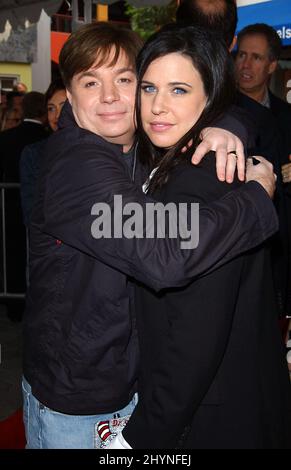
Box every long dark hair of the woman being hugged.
[136,24,235,192]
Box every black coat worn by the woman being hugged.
[123,155,291,449]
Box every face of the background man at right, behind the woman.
[235,34,277,99]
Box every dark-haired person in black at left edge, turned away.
[0,92,48,320]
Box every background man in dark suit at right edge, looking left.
[235,23,291,316]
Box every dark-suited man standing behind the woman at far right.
[235,23,291,315]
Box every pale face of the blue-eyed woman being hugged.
[141,53,207,148]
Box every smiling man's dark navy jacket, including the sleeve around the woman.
[24,104,277,414]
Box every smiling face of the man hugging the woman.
[67,50,136,151]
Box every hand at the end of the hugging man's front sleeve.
[246,156,277,198]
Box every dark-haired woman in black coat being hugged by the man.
[109,26,291,449]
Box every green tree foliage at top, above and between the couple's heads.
[125,0,177,39]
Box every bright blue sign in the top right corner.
[237,0,291,46]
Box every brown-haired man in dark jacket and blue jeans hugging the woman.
[23,23,276,448]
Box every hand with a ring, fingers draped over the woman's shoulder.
[192,127,246,183]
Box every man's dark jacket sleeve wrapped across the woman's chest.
[37,143,277,290]
